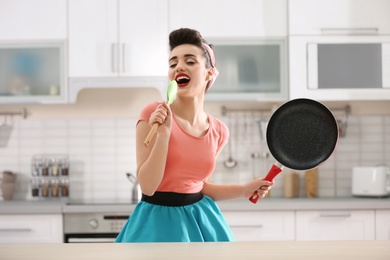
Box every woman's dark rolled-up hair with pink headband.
[169,28,213,68]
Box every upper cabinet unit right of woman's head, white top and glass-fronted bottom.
[169,0,288,102]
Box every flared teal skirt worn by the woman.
[115,196,235,243]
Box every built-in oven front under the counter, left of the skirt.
[64,212,130,243]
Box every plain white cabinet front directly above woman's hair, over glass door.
[169,0,287,39]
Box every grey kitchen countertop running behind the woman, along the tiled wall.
[0,197,390,214]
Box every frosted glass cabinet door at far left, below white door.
[0,40,68,104]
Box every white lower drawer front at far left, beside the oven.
[0,214,63,243]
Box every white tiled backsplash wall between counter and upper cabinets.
[0,116,390,201]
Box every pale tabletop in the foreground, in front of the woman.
[0,241,390,260]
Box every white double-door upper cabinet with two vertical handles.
[69,0,168,77]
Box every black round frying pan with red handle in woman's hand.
[249,98,339,203]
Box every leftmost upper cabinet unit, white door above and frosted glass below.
[0,0,67,104]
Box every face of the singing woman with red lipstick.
[168,44,212,94]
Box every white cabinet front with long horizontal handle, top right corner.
[289,0,390,35]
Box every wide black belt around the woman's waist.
[141,191,203,207]
